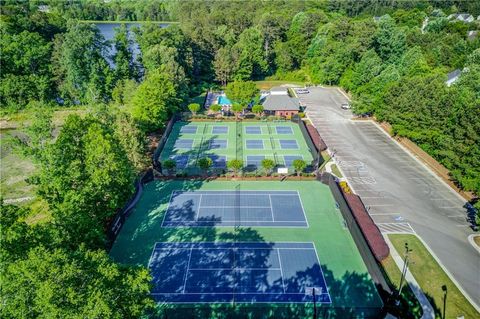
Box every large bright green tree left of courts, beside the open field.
[36,115,135,247]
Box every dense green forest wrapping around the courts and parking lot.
[0,0,480,318]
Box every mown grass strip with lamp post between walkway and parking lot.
[389,235,480,319]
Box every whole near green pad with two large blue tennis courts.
[109,179,382,318]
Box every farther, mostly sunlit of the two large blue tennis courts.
[162,190,308,227]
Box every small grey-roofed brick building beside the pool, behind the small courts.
[261,87,300,116]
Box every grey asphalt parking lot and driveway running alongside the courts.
[299,88,480,309]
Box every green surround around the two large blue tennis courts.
[110,180,382,318]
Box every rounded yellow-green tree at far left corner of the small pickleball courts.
[131,72,179,131]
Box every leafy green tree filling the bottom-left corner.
[2,247,154,318]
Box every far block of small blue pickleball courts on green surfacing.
[160,121,313,173]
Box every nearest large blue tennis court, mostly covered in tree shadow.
[148,242,331,303]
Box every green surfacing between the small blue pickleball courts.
[160,121,313,173]
